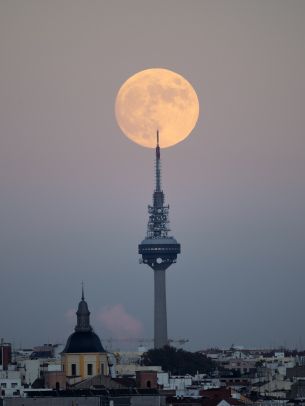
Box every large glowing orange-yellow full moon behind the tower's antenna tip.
[115,68,199,148]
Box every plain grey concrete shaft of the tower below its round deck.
[154,269,168,348]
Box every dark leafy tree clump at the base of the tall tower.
[141,346,216,375]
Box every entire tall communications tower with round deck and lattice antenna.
[139,131,180,348]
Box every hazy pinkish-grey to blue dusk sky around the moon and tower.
[0,0,305,349]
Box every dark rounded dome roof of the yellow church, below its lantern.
[63,331,105,354]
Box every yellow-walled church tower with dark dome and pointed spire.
[62,289,109,384]
